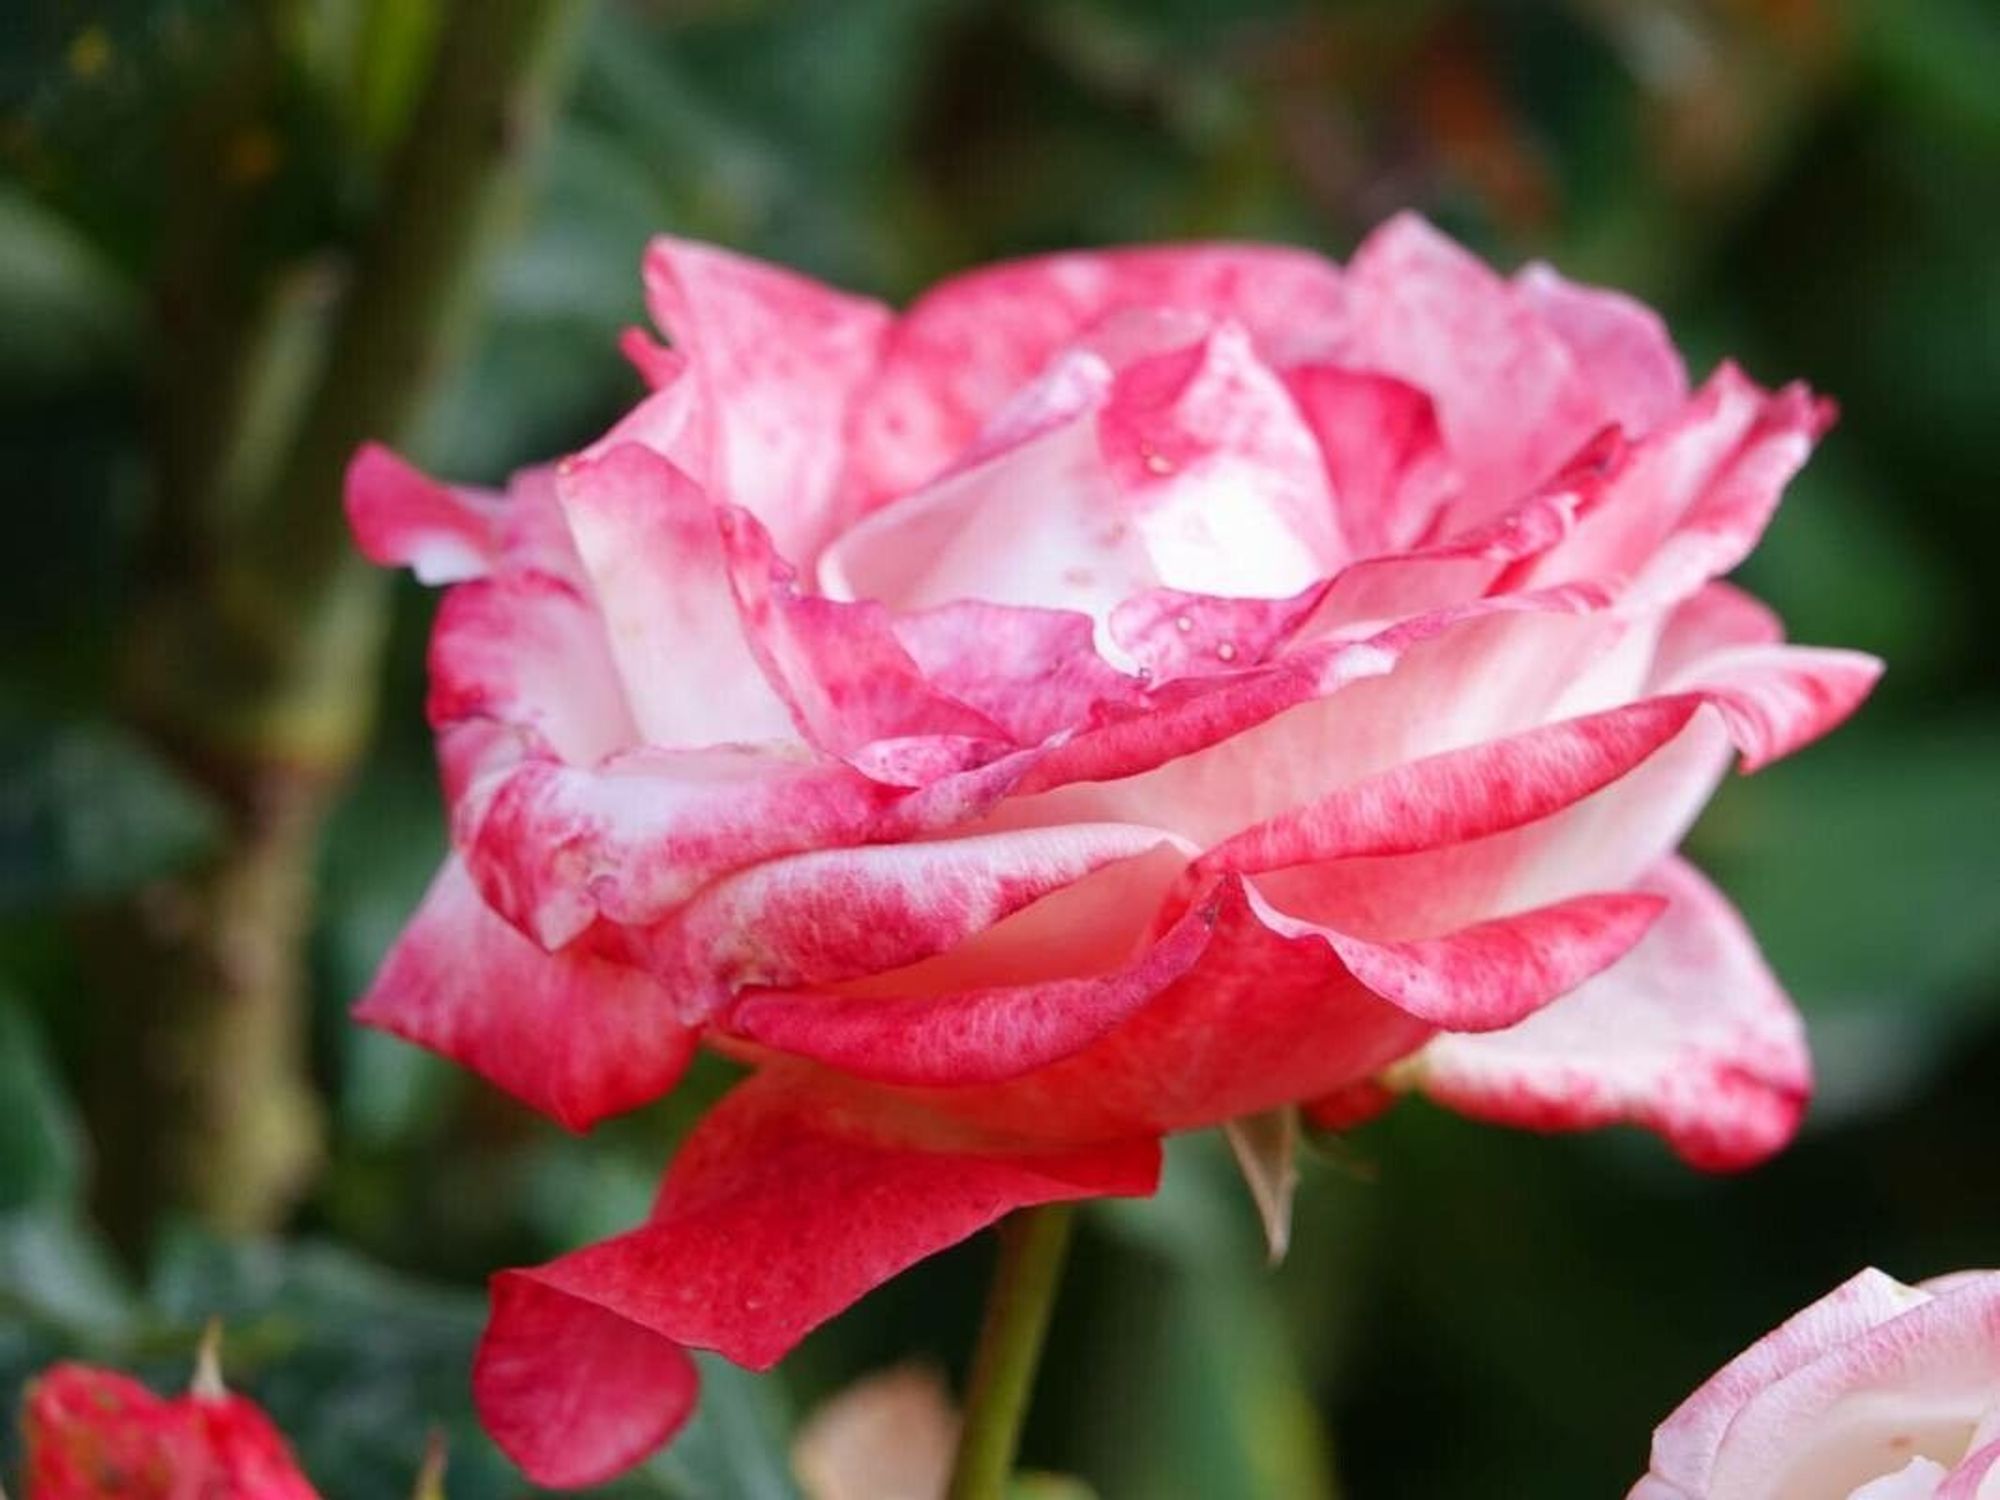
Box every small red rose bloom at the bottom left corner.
[22,1364,316,1500]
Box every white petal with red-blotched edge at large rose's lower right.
[1408,860,1812,1170]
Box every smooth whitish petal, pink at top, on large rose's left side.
[556,444,794,748]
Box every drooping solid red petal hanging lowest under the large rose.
[474,1076,1158,1486]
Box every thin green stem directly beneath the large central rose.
[950,1204,1076,1500]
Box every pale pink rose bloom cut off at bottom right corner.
[1630,1270,2000,1500]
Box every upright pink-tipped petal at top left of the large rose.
[646,236,890,560]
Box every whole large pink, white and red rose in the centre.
[348,218,1880,1484]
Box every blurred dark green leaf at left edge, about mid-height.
[0,724,222,908]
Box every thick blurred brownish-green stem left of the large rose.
[86,0,586,1252]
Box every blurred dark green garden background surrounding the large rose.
[0,0,2000,1500]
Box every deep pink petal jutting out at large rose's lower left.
[354,858,696,1130]
